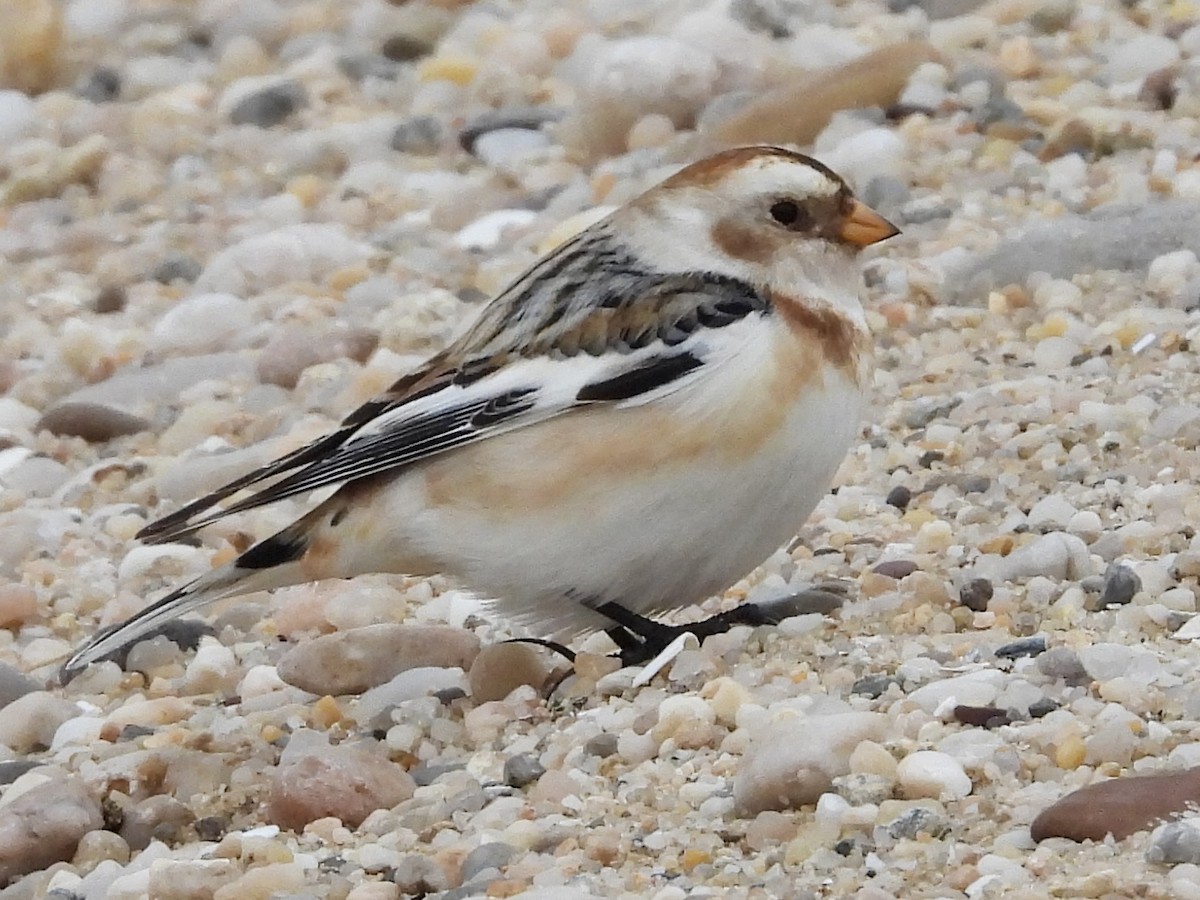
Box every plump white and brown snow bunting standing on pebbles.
[61,145,899,682]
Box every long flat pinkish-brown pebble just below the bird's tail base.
[276,623,479,696]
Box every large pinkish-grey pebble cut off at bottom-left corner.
[0,778,104,884]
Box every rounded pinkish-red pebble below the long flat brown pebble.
[266,734,415,830]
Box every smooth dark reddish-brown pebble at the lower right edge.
[1030,768,1200,841]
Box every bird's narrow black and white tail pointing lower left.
[59,520,308,684]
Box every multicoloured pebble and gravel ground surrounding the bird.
[0,0,1200,900]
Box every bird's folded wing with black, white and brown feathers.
[139,229,769,542]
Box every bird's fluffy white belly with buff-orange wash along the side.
[384,338,862,637]
